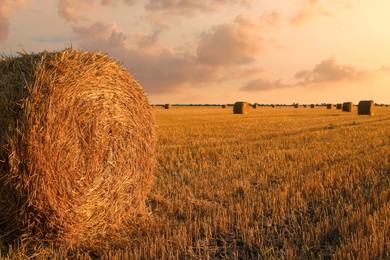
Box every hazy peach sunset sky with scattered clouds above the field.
[0,0,390,104]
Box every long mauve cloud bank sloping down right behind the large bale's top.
[73,23,218,94]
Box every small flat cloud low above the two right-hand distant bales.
[295,58,373,86]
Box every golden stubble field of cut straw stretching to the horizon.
[3,107,390,259]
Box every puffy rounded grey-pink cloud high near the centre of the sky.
[197,16,264,66]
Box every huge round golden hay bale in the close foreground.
[0,49,156,248]
